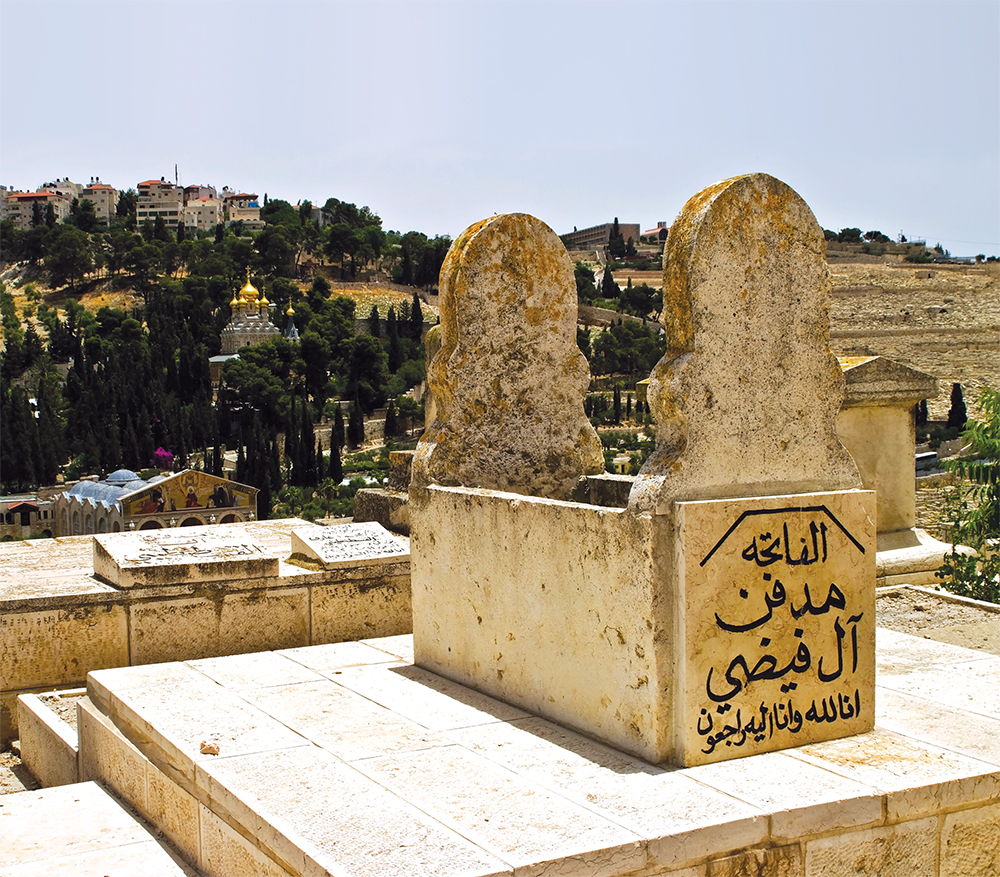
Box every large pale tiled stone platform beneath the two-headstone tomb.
[80,629,1000,877]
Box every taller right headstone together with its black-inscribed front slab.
[630,174,875,764]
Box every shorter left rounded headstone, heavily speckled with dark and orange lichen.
[413,213,604,499]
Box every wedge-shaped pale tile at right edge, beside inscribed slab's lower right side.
[879,656,1000,719]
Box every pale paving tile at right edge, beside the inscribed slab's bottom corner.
[875,687,1000,765]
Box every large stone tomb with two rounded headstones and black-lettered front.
[410,174,876,765]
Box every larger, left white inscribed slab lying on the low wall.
[94,527,279,588]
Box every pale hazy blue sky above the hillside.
[0,0,1000,255]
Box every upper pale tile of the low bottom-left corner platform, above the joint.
[0,783,158,866]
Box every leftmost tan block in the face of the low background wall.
[0,603,128,691]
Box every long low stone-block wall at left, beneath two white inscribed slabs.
[0,520,411,741]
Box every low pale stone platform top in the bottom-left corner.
[0,783,197,877]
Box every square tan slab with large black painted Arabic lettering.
[675,491,875,765]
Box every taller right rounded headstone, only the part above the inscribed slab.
[630,174,861,511]
